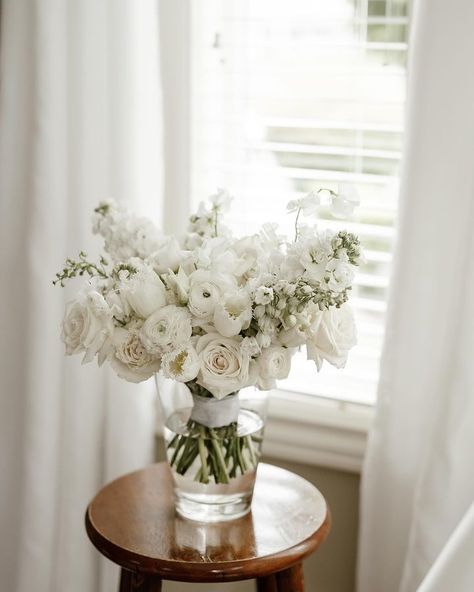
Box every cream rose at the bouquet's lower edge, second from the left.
[110,328,160,382]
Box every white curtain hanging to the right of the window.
[358,0,474,592]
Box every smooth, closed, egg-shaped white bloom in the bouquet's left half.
[119,266,166,319]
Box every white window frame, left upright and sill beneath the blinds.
[158,0,382,473]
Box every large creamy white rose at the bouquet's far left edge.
[61,291,114,363]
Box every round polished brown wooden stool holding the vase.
[86,463,330,592]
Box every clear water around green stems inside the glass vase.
[164,407,263,522]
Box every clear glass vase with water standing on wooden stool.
[157,377,267,522]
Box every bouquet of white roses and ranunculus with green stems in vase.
[54,189,361,483]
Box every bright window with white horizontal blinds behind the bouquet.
[190,0,409,404]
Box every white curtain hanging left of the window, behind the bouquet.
[0,0,162,592]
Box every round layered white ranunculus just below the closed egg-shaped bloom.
[140,304,192,354]
